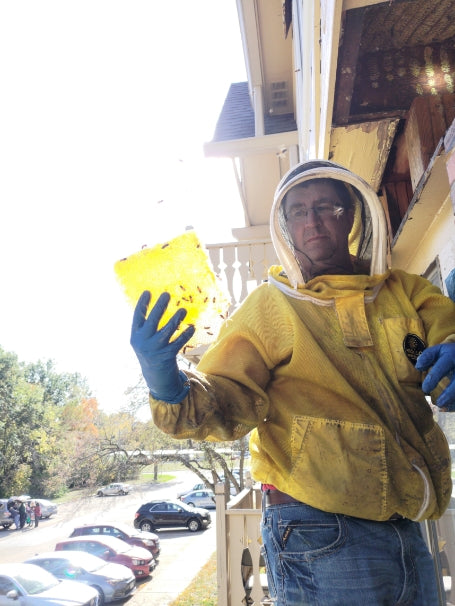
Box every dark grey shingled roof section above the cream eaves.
[212,82,297,143]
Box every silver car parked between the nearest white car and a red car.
[26,551,136,606]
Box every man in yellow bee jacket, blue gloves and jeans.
[131,161,455,606]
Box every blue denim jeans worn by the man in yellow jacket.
[261,503,438,606]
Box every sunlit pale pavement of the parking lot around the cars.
[0,471,216,606]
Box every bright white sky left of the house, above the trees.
[0,0,246,412]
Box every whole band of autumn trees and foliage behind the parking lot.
[0,348,246,498]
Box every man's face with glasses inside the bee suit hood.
[284,181,354,280]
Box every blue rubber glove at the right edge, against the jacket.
[416,343,455,412]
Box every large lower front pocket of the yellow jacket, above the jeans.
[291,416,388,520]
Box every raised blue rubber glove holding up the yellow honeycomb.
[130,291,194,404]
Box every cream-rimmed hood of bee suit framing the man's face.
[270,160,388,288]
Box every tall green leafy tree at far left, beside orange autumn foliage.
[0,349,94,496]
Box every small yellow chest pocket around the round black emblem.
[383,317,425,383]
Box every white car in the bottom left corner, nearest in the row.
[0,563,98,606]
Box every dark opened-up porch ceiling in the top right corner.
[332,0,455,126]
